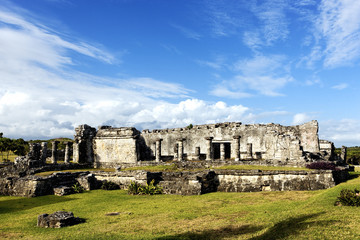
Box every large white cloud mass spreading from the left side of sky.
[0,4,253,139]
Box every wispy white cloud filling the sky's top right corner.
[309,0,360,67]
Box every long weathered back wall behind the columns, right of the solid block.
[141,121,319,161]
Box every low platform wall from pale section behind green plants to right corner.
[94,170,338,195]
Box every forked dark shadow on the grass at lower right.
[251,212,335,240]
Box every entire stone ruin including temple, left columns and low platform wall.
[0,121,348,197]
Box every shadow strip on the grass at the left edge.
[0,195,74,214]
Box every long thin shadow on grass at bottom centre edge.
[155,225,262,240]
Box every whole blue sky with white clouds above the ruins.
[0,0,360,146]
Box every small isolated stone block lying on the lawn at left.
[37,211,84,228]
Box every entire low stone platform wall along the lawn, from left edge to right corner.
[0,170,347,197]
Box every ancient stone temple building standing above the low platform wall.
[74,121,332,167]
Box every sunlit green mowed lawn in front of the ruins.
[0,175,360,239]
